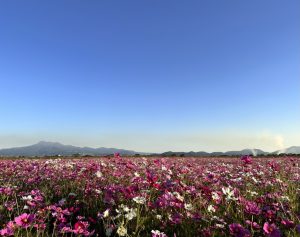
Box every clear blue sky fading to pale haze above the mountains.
[0,0,300,152]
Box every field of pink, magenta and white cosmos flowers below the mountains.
[0,156,300,237]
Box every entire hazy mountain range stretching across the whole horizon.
[0,141,300,157]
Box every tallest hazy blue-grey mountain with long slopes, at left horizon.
[0,141,137,156]
